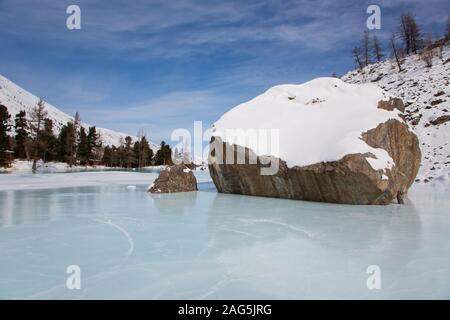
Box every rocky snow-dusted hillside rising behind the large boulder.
[342,45,450,182]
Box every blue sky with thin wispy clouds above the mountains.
[0,0,450,142]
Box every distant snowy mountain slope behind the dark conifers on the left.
[0,75,158,150]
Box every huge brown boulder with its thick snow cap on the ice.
[209,78,421,204]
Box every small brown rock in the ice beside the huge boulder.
[148,164,198,193]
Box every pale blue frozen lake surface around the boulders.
[0,172,450,299]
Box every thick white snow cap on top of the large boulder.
[213,78,400,170]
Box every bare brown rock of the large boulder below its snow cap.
[209,77,421,205]
